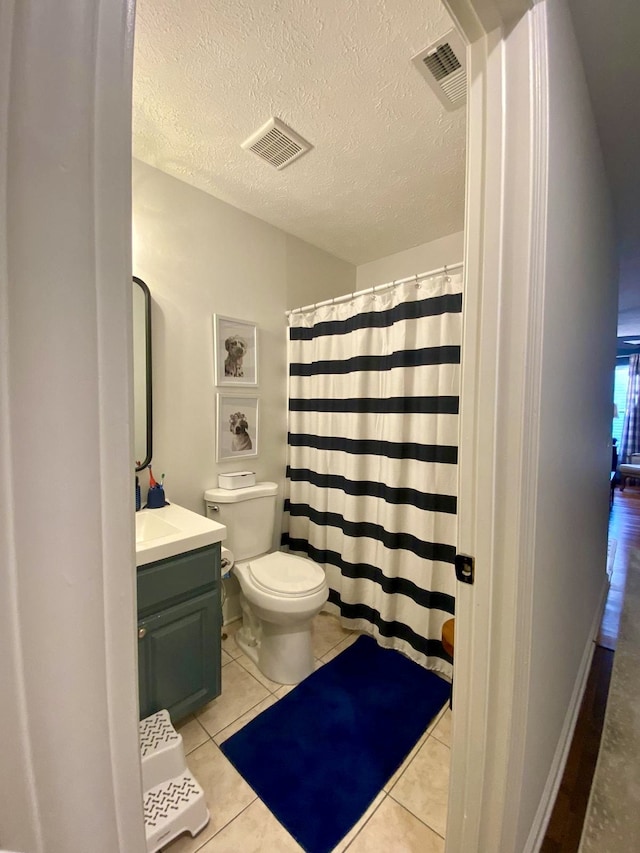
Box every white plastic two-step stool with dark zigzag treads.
[140,710,209,853]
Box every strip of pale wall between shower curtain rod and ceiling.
[356,231,464,290]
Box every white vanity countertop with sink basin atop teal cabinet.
[136,504,227,566]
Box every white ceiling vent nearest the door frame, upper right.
[411,30,467,110]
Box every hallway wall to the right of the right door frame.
[516,0,617,850]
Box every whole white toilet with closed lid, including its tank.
[204,483,329,684]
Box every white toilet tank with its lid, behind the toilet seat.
[204,483,278,560]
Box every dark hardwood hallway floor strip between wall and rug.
[540,487,640,853]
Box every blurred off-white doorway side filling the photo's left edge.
[0,0,146,853]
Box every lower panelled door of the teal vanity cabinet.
[138,589,220,720]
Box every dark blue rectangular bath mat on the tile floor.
[220,636,450,853]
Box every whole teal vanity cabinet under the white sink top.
[137,543,221,720]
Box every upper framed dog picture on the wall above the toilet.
[213,314,258,385]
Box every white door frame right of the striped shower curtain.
[443,0,548,853]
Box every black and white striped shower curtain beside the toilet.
[282,273,462,675]
